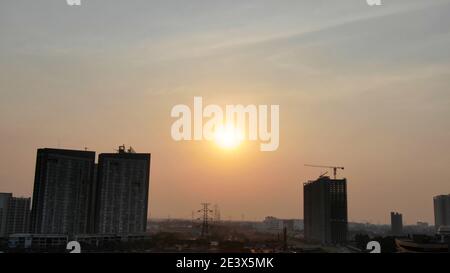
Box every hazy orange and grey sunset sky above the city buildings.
[0,0,450,224]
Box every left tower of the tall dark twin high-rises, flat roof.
[31,148,95,235]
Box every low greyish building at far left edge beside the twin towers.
[0,193,31,237]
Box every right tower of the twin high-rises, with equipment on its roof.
[95,146,150,234]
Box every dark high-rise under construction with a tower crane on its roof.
[303,176,348,244]
